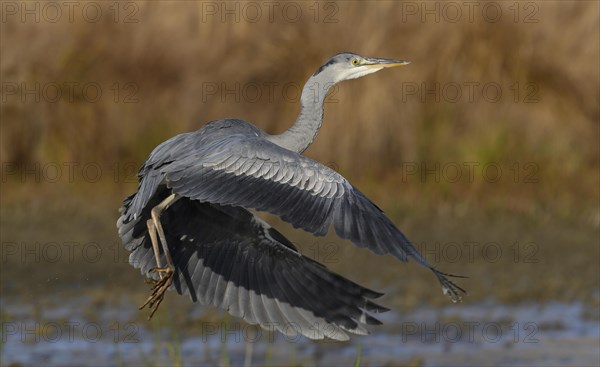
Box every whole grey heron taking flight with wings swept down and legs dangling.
[117,53,465,340]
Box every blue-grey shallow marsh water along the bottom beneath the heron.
[2,297,600,366]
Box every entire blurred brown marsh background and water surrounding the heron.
[0,1,600,366]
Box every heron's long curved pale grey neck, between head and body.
[268,73,333,153]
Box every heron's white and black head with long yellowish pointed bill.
[313,52,410,83]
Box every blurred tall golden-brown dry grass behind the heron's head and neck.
[0,1,600,216]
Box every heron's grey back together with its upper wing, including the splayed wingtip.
[125,120,465,302]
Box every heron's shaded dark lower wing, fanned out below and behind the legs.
[118,186,387,340]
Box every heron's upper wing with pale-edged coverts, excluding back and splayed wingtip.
[161,134,418,261]
